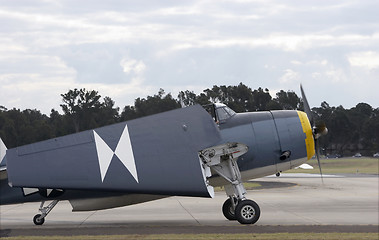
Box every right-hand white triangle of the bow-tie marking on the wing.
[115,125,138,183]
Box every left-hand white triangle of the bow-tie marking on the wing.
[93,131,114,182]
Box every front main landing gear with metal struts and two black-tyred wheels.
[199,143,261,224]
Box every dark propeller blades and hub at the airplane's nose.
[300,84,328,183]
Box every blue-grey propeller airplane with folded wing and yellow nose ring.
[0,85,327,225]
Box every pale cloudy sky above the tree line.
[0,0,379,114]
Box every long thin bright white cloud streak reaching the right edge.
[158,33,379,54]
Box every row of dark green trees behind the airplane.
[0,83,379,155]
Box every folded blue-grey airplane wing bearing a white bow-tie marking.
[7,105,221,197]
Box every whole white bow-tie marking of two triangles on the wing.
[93,125,138,183]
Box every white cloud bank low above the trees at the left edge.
[0,74,155,114]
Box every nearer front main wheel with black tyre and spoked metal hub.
[235,200,261,224]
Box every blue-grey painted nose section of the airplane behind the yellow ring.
[220,110,307,173]
